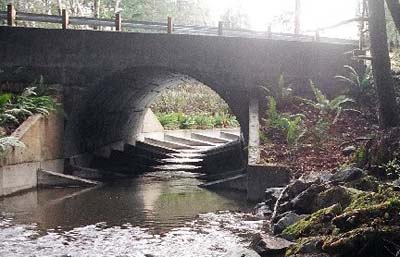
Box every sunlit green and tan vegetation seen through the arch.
[151,83,239,129]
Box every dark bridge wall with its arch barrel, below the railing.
[0,27,356,157]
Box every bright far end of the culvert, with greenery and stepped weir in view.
[136,79,244,174]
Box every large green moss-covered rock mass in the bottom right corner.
[282,184,400,257]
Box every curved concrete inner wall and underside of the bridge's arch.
[65,66,248,157]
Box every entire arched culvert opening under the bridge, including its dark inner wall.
[73,67,246,176]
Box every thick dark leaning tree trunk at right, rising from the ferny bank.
[368,0,399,128]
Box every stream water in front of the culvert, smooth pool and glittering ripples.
[0,172,261,257]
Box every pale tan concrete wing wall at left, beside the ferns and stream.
[0,114,64,196]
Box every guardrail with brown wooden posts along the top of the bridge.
[0,4,358,45]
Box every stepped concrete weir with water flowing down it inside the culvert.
[131,129,245,174]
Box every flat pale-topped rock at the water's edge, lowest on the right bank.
[250,234,294,256]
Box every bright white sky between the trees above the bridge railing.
[206,0,358,38]
